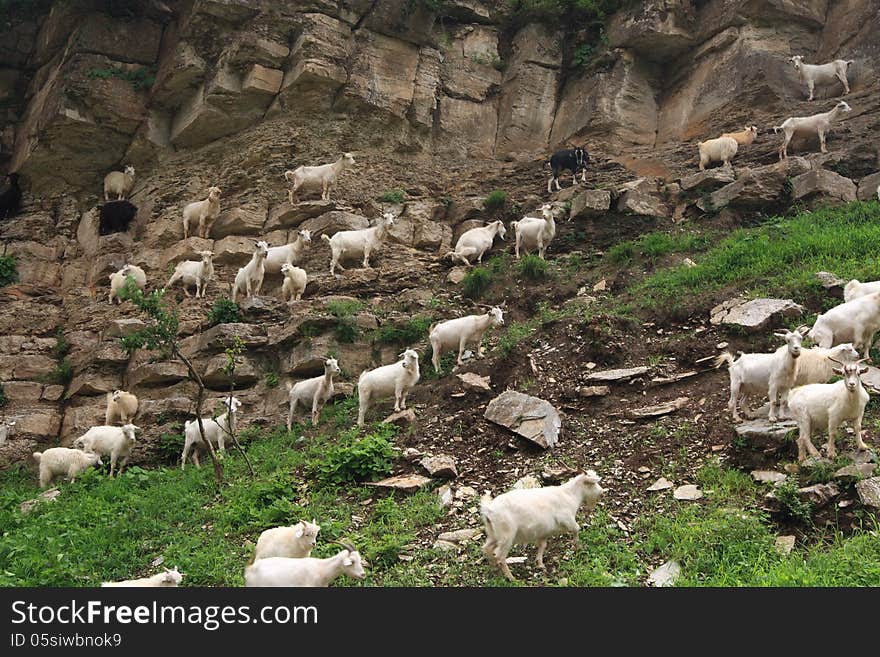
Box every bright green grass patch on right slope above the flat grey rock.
[630,201,880,308]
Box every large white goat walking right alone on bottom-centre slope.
[480,470,605,581]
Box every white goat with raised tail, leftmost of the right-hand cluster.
[715,326,807,422]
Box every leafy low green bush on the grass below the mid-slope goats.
[309,425,396,484]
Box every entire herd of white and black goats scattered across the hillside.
[4,51,880,586]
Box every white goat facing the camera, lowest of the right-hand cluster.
[788,359,869,462]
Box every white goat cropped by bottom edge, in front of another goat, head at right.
[244,549,369,587]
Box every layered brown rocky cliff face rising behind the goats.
[0,0,880,466]
